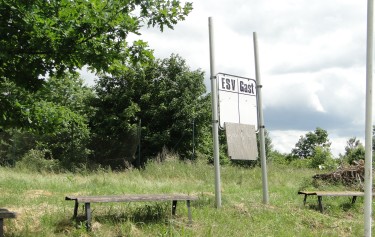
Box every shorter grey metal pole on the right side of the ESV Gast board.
[253,32,269,204]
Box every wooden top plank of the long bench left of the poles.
[65,194,198,203]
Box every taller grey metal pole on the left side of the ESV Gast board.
[208,17,221,208]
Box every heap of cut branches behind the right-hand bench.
[313,160,365,186]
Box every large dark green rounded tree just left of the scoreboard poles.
[91,55,210,166]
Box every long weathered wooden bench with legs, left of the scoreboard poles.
[65,194,198,230]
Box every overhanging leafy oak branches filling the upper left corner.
[0,0,192,89]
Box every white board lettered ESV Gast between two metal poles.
[217,73,258,129]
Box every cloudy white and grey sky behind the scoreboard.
[84,0,367,156]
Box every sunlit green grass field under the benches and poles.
[0,159,374,237]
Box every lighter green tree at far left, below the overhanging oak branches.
[0,73,93,168]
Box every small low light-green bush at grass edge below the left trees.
[16,149,60,173]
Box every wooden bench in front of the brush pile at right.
[298,191,374,212]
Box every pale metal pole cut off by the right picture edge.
[364,0,374,237]
